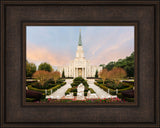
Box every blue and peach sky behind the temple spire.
[26,26,134,67]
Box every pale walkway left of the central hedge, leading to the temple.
[46,79,73,99]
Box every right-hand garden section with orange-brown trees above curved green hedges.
[95,68,134,102]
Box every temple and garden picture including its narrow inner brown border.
[23,23,138,105]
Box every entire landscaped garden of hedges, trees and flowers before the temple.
[26,60,134,103]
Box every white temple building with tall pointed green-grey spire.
[57,31,102,79]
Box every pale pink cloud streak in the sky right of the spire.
[88,33,134,65]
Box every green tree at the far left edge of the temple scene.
[26,60,36,77]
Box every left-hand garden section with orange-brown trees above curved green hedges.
[26,70,66,102]
